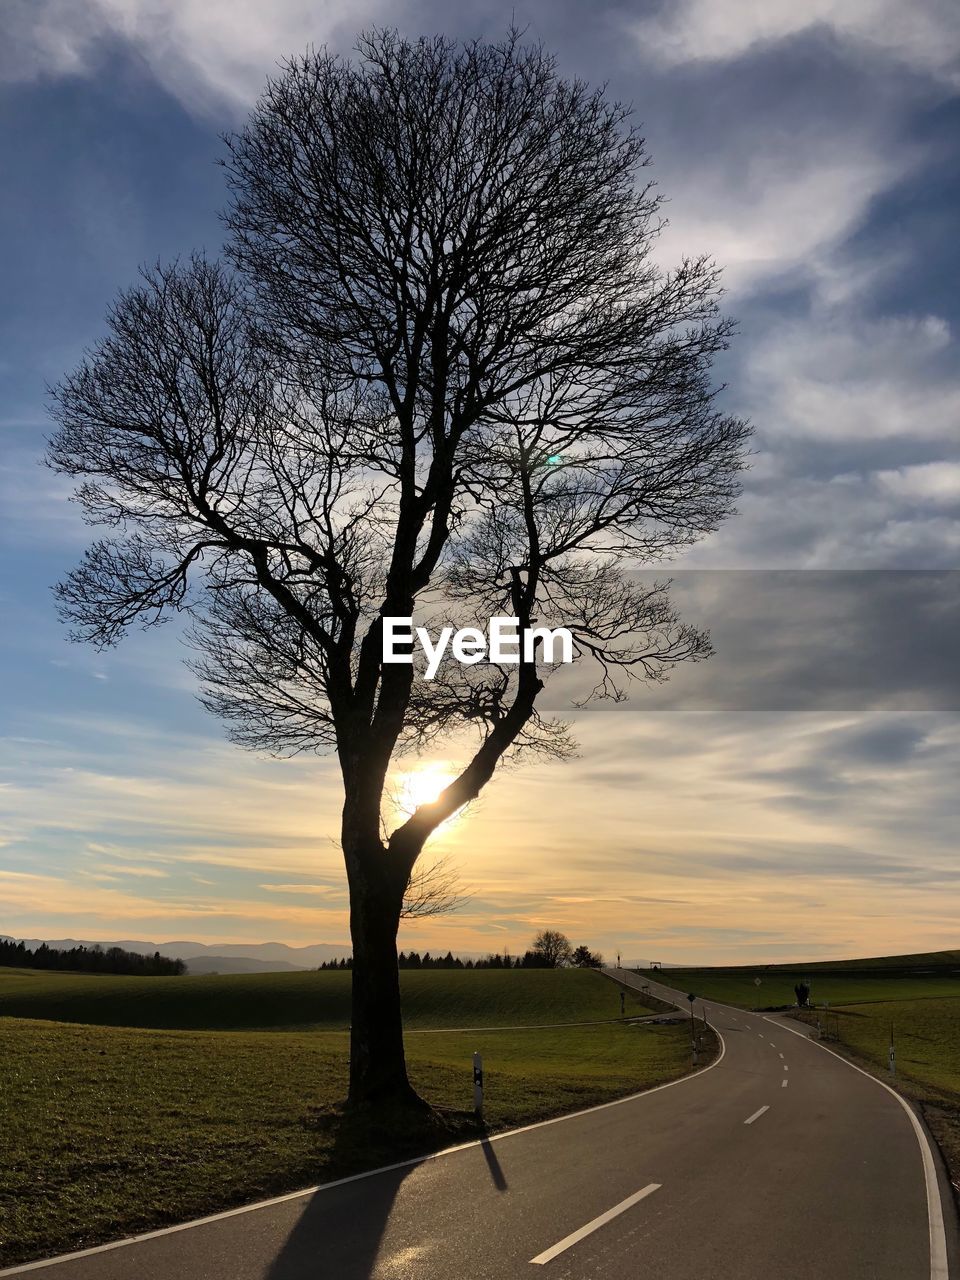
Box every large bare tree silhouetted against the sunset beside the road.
[50,32,748,1106]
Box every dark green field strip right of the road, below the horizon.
[641,965,960,1009]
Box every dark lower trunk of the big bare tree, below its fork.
[347,849,426,1110]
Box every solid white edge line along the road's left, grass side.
[0,1023,727,1280]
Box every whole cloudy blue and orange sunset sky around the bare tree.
[0,0,960,963]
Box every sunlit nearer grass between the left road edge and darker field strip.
[0,1008,708,1266]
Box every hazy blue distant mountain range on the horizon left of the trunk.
[0,934,351,974]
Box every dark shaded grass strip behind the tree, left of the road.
[0,969,646,1030]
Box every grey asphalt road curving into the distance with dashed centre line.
[0,974,955,1280]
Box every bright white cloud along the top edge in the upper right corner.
[631,0,960,84]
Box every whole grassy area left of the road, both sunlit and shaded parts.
[0,970,706,1265]
